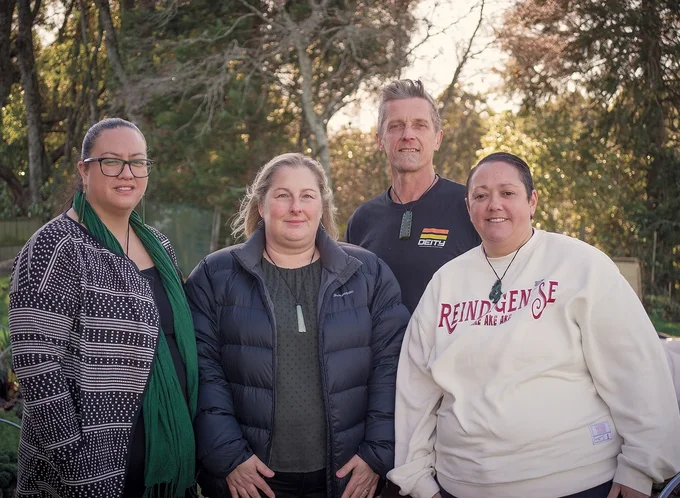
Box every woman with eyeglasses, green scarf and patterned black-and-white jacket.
[9,119,198,498]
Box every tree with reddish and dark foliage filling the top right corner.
[499,0,680,294]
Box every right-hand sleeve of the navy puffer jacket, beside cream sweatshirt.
[358,260,409,477]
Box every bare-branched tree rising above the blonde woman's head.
[136,0,416,178]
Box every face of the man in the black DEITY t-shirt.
[376,98,443,173]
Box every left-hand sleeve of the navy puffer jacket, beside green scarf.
[186,260,253,477]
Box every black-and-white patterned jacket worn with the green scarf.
[9,215,176,498]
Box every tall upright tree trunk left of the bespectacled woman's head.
[16,0,45,204]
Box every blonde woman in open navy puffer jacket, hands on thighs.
[187,154,409,498]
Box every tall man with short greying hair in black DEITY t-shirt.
[345,80,480,313]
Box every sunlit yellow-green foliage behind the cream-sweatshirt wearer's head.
[480,93,645,257]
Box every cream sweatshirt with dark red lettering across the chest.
[388,230,680,498]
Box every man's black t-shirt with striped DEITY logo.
[345,178,481,313]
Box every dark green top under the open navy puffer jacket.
[262,258,326,472]
